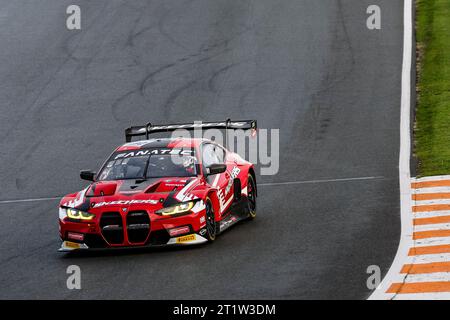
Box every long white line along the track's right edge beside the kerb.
[369,0,413,299]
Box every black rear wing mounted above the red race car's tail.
[125,119,257,142]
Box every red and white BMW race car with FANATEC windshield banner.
[59,120,257,251]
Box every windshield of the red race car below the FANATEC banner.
[99,155,197,180]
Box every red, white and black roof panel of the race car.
[116,138,212,151]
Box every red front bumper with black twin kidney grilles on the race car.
[58,206,207,252]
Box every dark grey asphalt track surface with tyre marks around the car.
[0,0,403,299]
